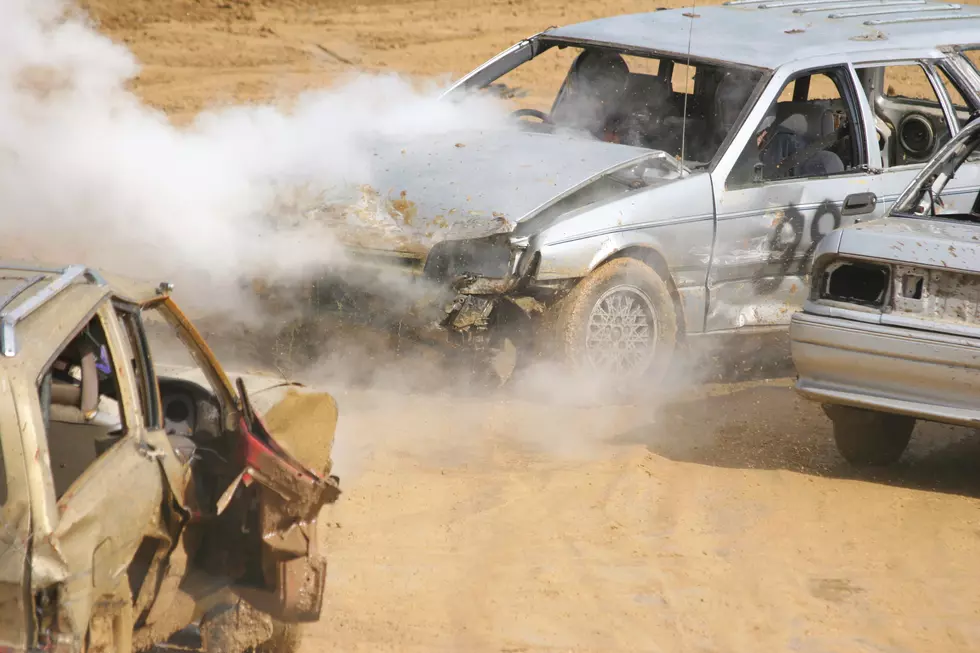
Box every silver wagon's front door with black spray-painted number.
[705,65,878,331]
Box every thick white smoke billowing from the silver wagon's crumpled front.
[0,0,505,308]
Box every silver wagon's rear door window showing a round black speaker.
[862,63,962,168]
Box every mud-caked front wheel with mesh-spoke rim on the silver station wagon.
[556,258,677,383]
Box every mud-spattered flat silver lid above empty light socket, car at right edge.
[838,217,980,272]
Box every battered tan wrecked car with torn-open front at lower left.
[0,264,339,653]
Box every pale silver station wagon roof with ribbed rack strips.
[544,0,980,69]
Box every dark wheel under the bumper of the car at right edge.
[824,405,915,467]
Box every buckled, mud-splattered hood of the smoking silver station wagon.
[310,130,659,254]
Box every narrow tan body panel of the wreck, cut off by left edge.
[0,372,33,650]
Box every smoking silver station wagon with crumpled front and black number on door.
[310,0,980,379]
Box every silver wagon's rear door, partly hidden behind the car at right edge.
[854,59,980,213]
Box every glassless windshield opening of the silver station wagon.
[472,41,763,165]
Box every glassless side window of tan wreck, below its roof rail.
[38,315,127,499]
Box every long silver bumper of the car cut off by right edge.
[790,312,980,427]
